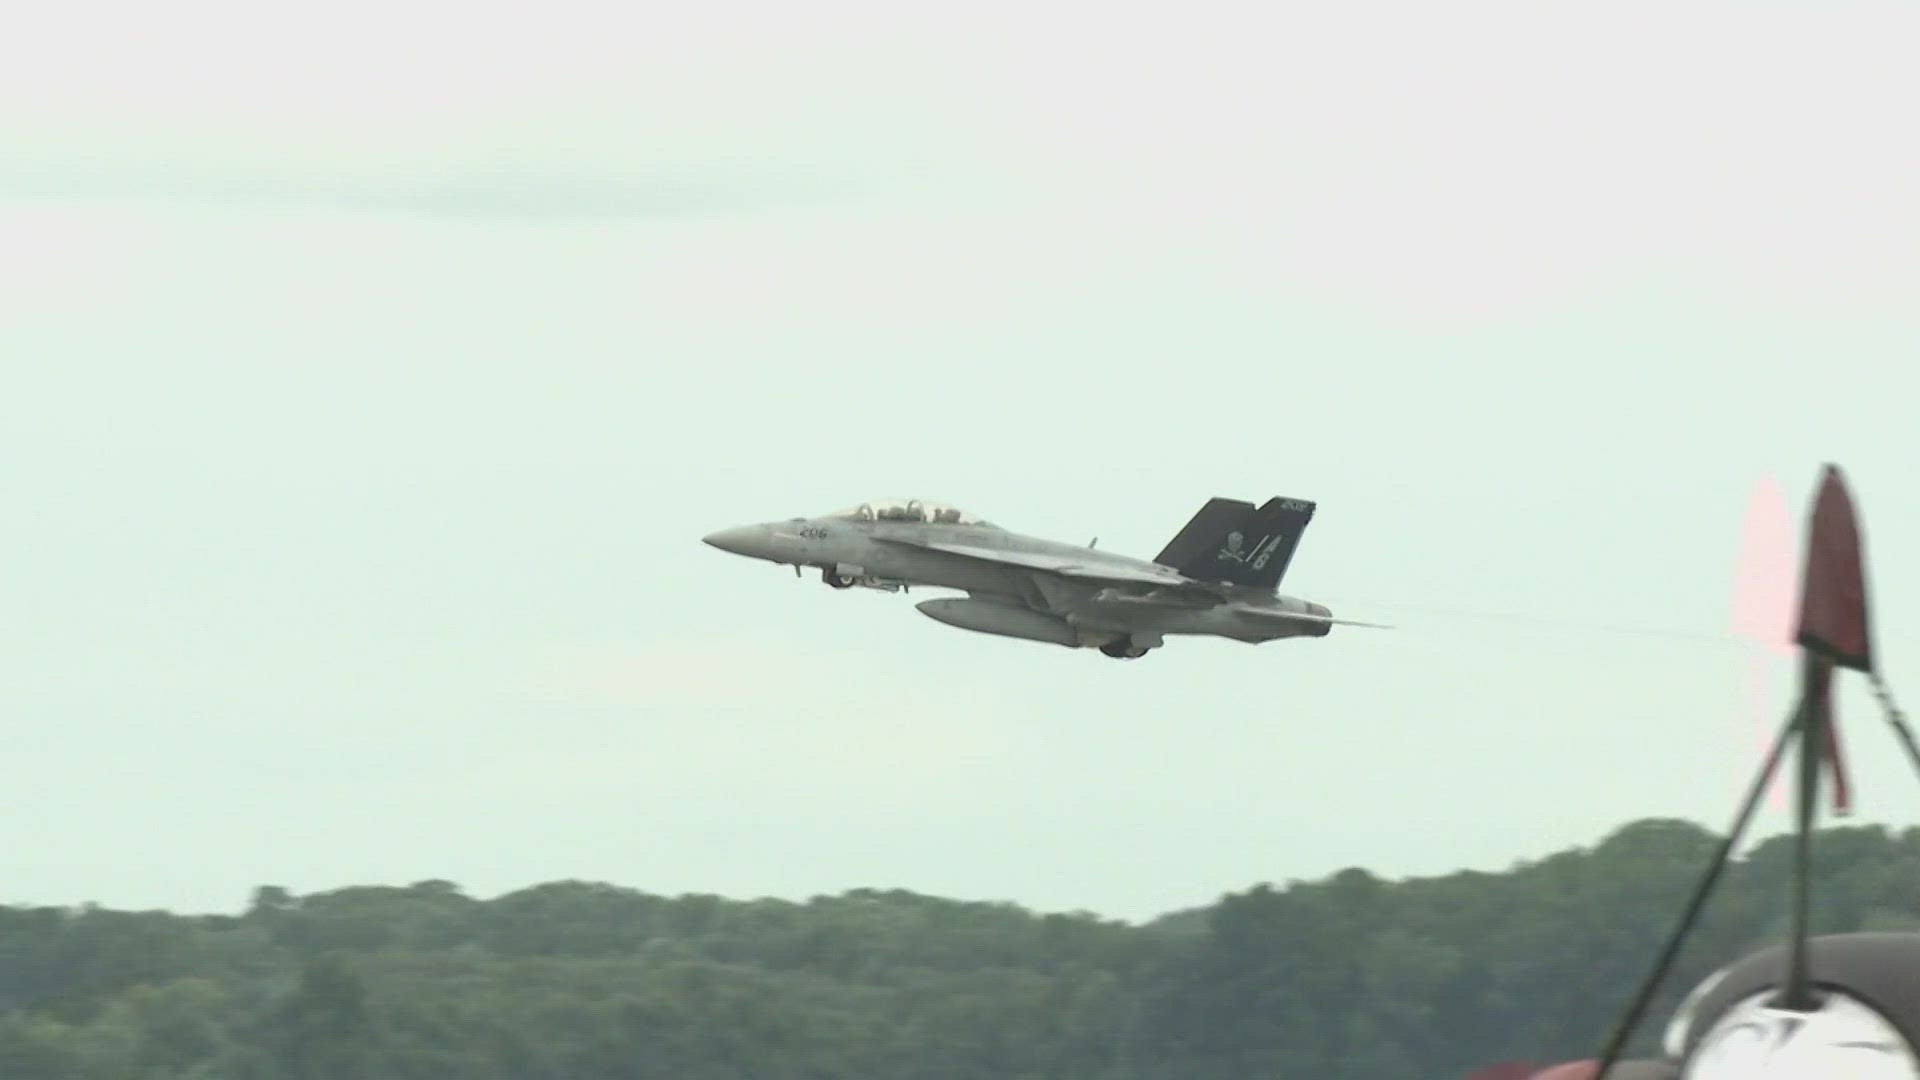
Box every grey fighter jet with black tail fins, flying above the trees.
[703,498,1373,659]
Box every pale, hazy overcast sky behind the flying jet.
[0,0,1920,917]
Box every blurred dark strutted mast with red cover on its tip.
[1594,465,1920,1080]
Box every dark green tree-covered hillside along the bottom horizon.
[0,821,1920,1080]
